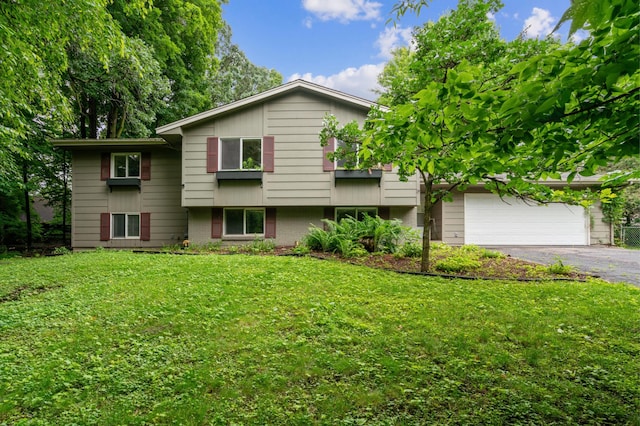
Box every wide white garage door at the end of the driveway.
[464,194,589,245]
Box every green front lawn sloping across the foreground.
[0,251,640,425]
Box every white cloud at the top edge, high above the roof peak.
[302,0,382,22]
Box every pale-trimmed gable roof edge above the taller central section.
[156,80,384,136]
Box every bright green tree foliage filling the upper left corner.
[0,0,124,183]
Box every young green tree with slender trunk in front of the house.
[321,0,554,271]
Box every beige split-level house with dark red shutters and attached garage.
[54,80,610,248]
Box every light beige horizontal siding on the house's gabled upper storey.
[182,92,419,207]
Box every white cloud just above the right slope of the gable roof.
[287,63,385,100]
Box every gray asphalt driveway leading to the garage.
[489,246,640,287]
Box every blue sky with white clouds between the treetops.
[223,0,569,100]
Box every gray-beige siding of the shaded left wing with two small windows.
[72,148,187,248]
